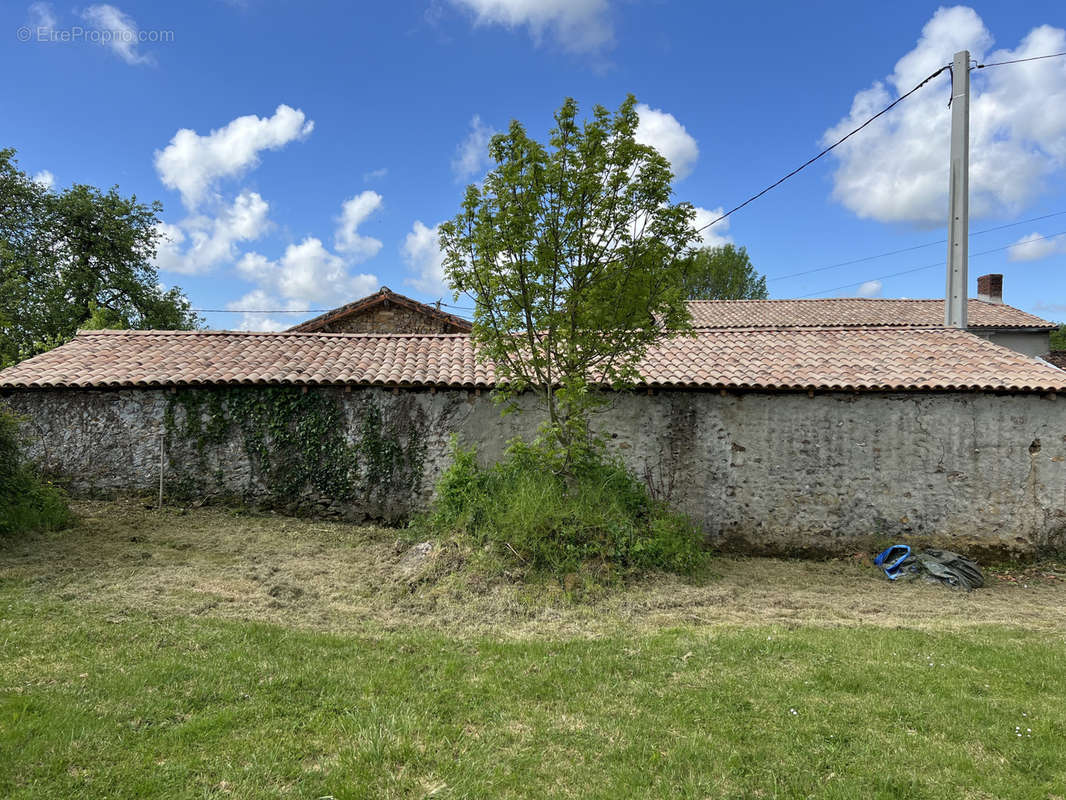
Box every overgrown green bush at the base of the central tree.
[419,442,706,574]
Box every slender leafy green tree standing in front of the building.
[440,96,696,457]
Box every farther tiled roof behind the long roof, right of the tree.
[689,298,1056,331]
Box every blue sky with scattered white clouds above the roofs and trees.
[0,0,1066,329]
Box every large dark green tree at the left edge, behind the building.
[0,148,201,366]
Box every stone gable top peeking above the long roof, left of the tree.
[289,286,470,334]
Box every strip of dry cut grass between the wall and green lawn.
[0,500,1066,637]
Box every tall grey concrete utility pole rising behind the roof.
[943,50,970,330]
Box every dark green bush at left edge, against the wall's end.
[0,409,71,535]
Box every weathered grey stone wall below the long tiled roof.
[7,387,1066,554]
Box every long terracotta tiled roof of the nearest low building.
[0,327,1066,391]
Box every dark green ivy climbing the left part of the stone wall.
[163,386,425,514]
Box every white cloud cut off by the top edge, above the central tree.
[451,0,614,53]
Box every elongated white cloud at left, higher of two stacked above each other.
[156,105,314,209]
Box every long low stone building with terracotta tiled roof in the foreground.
[0,320,1066,555]
